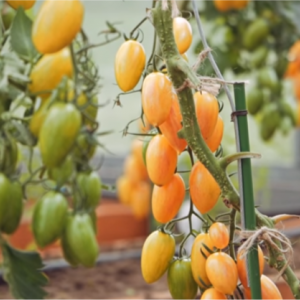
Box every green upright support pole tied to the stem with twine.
[234,83,262,300]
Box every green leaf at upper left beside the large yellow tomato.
[10,7,37,61]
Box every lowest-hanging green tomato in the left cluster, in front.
[64,214,99,267]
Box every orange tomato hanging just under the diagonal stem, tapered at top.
[190,161,221,214]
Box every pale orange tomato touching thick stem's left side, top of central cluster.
[142,72,174,126]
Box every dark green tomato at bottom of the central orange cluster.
[168,258,198,300]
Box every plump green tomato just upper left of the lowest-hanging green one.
[32,191,68,248]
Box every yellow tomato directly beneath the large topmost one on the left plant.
[28,48,73,99]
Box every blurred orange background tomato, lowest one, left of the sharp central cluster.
[130,181,151,219]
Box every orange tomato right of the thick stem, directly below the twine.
[194,92,219,139]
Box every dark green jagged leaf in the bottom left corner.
[1,243,48,300]
